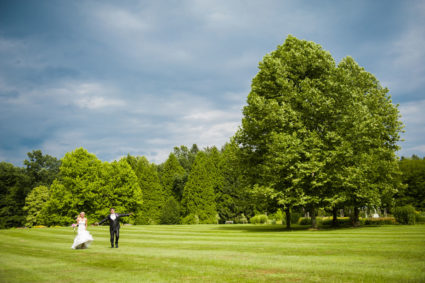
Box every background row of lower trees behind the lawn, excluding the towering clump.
[0,146,425,228]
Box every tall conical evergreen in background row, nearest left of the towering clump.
[182,151,217,224]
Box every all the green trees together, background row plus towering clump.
[0,36,425,227]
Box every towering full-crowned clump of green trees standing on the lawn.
[236,36,401,226]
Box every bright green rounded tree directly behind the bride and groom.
[44,148,142,225]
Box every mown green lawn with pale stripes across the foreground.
[0,225,425,282]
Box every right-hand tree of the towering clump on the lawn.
[335,57,403,225]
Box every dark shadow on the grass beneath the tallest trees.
[215,224,362,233]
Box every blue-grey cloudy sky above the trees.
[0,0,425,165]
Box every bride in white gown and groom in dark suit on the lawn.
[71,208,133,249]
